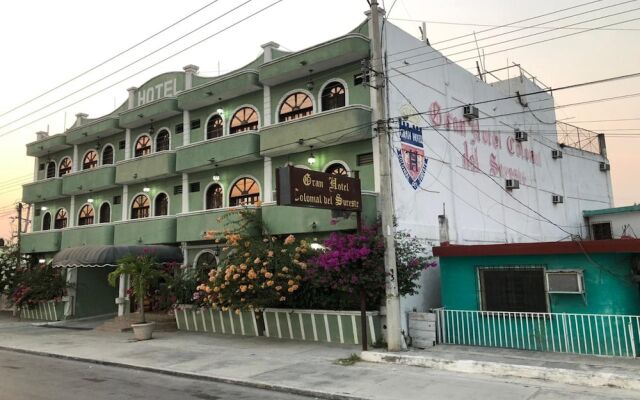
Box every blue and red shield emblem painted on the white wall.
[396,120,428,189]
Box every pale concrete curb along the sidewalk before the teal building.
[361,351,640,390]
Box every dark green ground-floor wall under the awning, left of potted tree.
[75,268,118,318]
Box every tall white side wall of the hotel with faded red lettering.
[385,23,612,322]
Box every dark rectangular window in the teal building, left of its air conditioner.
[479,268,547,312]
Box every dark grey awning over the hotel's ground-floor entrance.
[52,246,182,268]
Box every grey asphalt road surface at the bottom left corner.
[0,351,311,400]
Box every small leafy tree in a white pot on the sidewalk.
[109,254,165,340]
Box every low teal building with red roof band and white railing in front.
[434,239,640,356]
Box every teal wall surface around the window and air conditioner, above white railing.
[440,254,640,315]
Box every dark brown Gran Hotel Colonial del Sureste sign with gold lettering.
[276,166,362,211]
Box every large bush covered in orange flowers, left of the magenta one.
[194,233,309,312]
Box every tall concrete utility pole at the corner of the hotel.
[371,0,404,351]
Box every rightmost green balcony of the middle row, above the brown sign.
[260,105,371,157]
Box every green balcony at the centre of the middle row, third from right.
[116,151,176,185]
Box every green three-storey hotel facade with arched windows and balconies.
[20,22,378,315]
